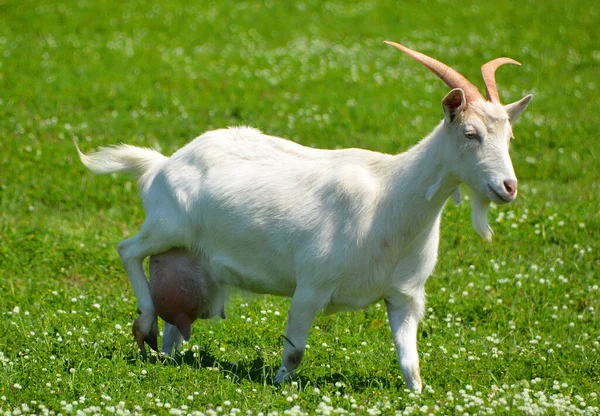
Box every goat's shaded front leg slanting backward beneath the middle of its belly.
[274,288,326,384]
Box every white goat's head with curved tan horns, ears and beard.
[385,41,533,241]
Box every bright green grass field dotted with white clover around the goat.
[0,0,600,414]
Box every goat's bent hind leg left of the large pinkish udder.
[117,229,171,355]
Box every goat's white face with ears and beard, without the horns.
[442,88,532,239]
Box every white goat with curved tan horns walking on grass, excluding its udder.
[78,42,532,391]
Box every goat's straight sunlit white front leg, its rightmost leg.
[385,295,424,393]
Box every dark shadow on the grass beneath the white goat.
[130,348,405,391]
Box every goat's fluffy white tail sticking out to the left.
[74,141,168,180]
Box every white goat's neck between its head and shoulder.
[386,124,459,236]
